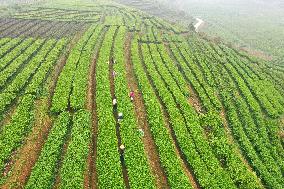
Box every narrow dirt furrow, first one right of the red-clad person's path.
[139,42,200,189]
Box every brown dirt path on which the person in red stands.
[124,34,170,189]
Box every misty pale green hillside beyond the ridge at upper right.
[157,0,284,58]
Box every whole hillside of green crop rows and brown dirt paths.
[0,0,284,189]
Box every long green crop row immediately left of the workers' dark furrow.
[96,26,125,188]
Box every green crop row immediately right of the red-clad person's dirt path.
[131,35,191,188]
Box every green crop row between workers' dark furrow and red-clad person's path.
[113,27,155,189]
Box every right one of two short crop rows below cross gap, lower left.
[59,110,92,188]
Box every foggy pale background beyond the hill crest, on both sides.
[0,0,284,62]
